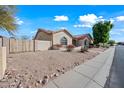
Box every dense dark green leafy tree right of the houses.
[92,21,113,45]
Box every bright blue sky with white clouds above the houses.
[0,5,124,41]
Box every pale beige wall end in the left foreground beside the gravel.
[0,47,6,79]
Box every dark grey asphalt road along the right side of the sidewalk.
[105,46,124,88]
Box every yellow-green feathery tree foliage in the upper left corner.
[0,5,17,34]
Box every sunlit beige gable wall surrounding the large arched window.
[53,32,72,45]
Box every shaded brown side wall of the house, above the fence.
[35,32,52,41]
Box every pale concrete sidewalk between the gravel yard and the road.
[45,47,115,88]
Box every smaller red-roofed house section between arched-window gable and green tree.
[73,34,93,47]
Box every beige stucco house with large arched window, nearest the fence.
[34,29,73,45]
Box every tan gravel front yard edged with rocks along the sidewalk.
[0,48,105,88]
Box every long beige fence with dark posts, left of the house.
[0,37,51,53]
